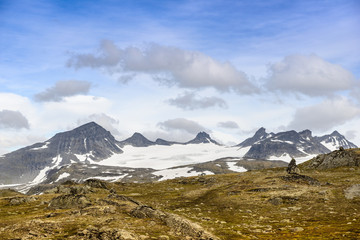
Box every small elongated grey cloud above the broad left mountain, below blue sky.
[34,80,91,102]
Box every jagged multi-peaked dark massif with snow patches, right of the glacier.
[236,128,356,159]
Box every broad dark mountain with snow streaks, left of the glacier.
[0,122,122,184]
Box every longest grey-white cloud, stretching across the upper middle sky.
[68,40,257,94]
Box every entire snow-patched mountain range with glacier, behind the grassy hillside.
[0,122,356,192]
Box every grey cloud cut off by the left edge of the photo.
[0,110,29,129]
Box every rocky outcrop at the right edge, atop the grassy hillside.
[308,148,360,169]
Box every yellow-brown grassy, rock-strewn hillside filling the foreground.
[0,151,360,239]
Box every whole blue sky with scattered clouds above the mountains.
[0,0,360,154]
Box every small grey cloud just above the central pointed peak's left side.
[158,118,209,134]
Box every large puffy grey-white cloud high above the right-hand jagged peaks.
[267,55,355,96]
